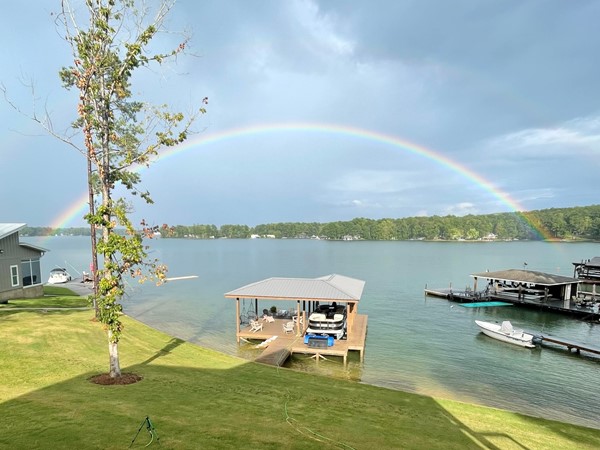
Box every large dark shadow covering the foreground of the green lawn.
[0,356,600,449]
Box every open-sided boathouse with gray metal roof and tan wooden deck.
[225,274,367,365]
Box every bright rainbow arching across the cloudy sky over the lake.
[51,119,552,240]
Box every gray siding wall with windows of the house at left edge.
[0,231,43,303]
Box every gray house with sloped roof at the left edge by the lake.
[0,223,48,303]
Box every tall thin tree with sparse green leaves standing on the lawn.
[59,0,206,377]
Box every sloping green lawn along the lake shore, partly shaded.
[0,290,600,450]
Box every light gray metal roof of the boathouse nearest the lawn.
[225,274,365,302]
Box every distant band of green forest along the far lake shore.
[21,205,600,241]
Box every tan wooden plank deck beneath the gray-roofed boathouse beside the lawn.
[238,314,367,366]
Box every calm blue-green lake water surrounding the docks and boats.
[34,237,600,428]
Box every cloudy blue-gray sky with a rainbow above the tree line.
[0,0,600,226]
